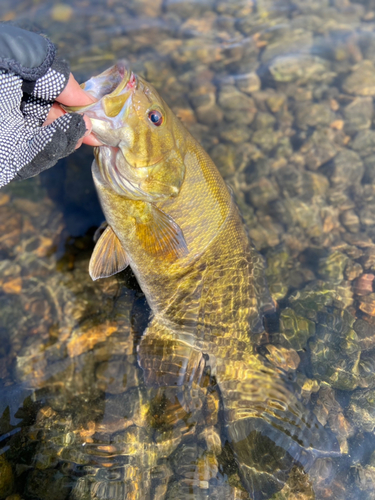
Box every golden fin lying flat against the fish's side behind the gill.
[136,205,188,261]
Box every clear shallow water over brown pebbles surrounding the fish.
[0,0,375,500]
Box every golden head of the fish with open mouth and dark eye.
[69,62,186,201]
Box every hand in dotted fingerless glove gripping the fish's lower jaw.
[0,23,97,187]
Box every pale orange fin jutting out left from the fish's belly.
[89,226,129,281]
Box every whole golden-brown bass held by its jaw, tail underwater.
[70,63,337,499]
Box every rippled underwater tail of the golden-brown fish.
[217,355,341,500]
